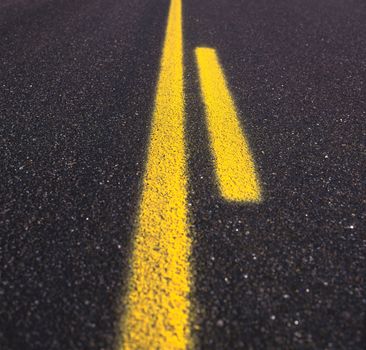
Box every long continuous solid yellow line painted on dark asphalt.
[121,0,191,350]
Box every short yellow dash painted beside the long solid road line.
[196,48,261,202]
